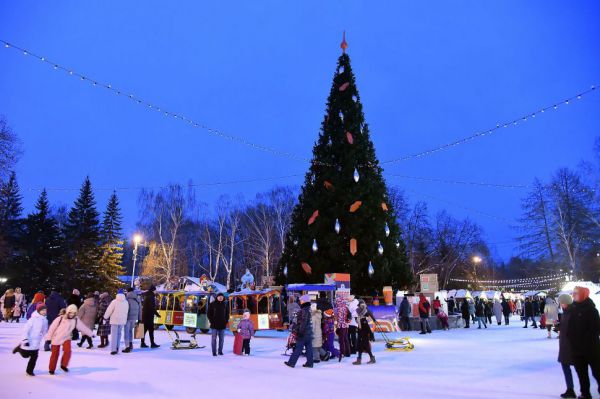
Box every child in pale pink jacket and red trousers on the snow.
[45,305,94,374]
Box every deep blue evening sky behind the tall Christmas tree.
[0,0,600,259]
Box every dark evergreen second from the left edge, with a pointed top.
[17,190,65,293]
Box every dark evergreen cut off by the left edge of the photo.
[0,172,23,281]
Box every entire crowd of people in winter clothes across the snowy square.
[0,286,600,399]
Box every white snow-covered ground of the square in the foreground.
[0,318,597,399]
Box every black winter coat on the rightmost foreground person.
[561,298,600,361]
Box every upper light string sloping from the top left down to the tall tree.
[0,39,314,166]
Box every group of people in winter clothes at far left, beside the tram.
[7,286,160,376]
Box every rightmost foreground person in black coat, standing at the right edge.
[567,287,600,399]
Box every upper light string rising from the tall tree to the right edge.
[381,85,596,165]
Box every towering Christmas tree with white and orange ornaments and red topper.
[277,37,412,295]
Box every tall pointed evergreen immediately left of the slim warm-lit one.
[64,177,104,292]
